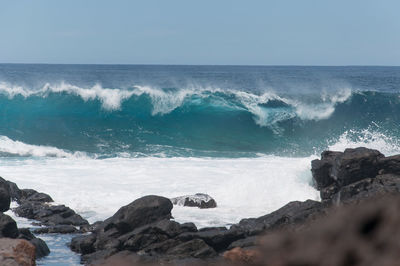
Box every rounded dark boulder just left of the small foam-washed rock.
[104,196,172,233]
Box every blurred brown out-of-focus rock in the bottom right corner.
[239,195,400,266]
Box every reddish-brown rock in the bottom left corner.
[0,238,36,266]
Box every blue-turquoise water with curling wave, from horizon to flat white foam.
[0,65,400,158]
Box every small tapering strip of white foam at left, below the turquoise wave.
[0,135,86,158]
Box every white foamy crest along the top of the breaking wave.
[0,82,351,126]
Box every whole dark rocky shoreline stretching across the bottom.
[0,147,400,265]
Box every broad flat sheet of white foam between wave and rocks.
[0,156,318,227]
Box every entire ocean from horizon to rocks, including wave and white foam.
[0,64,400,265]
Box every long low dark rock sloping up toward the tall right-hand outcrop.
[231,200,324,235]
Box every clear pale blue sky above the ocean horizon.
[0,0,400,65]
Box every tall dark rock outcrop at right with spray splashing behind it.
[311,147,400,204]
